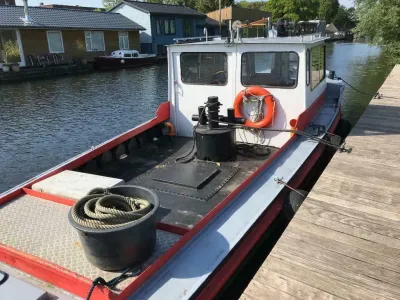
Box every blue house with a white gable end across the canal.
[110,0,209,55]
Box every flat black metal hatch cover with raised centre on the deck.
[135,161,238,201]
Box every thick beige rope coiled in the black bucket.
[71,188,152,229]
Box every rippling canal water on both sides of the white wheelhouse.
[0,43,391,194]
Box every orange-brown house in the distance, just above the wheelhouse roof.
[207,5,272,37]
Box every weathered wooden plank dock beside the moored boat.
[241,65,400,300]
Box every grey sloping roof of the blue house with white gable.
[116,0,206,18]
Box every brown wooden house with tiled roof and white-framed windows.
[0,5,145,66]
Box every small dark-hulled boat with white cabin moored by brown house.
[93,50,165,70]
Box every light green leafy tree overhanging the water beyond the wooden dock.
[354,0,400,63]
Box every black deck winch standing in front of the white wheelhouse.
[192,96,244,162]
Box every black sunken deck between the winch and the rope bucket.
[83,136,278,228]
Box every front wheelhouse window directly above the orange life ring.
[241,52,299,88]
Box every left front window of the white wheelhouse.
[180,52,228,85]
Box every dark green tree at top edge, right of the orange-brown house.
[265,0,319,21]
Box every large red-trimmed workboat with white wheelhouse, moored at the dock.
[0,24,348,299]
